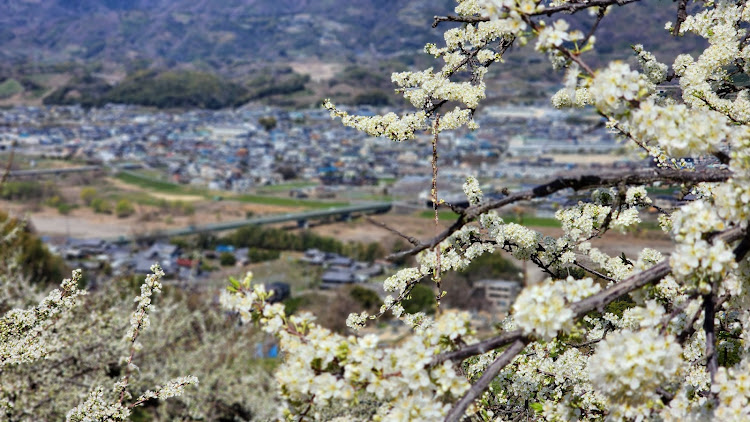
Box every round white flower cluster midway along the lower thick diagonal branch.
[513,277,601,339]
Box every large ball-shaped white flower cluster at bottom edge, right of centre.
[588,328,682,420]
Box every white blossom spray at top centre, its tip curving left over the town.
[323,0,552,141]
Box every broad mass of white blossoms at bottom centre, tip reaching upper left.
[222,282,474,421]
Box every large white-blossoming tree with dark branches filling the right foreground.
[223,0,750,421]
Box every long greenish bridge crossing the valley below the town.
[107,202,393,243]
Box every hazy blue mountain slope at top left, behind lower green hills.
[0,0,454,67]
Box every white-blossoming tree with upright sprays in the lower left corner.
[0,213,198,421]
